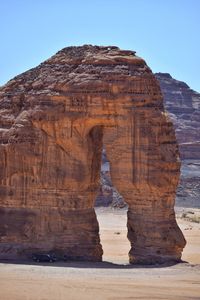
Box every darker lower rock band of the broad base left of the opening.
[0,207,103,261]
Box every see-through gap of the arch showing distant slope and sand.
[95,146,130,264]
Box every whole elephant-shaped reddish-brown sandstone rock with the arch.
[0,45,185,263]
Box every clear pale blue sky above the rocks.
[0,0,200,91]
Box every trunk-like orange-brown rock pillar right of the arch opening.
[104,109,186,264]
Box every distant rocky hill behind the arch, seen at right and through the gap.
[96,73,200,207]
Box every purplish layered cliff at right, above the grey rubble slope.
[155,73,200,160]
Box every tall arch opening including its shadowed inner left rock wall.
[87,125,130,264]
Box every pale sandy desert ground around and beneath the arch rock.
[0,208,200,300]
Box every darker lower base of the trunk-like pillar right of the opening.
[127,201,186,264]
